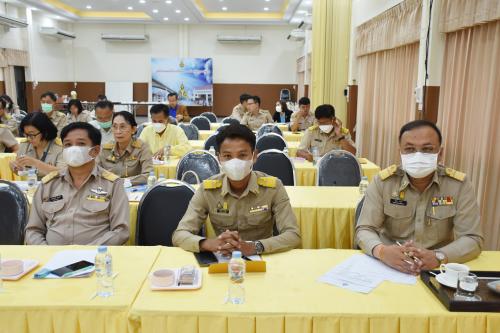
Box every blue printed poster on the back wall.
[150,58,213,106]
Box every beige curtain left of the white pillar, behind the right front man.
[356,43,419,167]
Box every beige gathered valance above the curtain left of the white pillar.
[356,0,422,57]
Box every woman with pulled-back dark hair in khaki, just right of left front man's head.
[98,111,153,185]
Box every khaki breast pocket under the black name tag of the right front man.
[384,204,415,238]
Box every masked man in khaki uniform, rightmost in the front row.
[356,120,483,274]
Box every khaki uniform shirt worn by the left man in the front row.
[26,165,129,245]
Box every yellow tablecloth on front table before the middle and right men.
[129,248,500,333]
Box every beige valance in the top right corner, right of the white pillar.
[439,0,500,32]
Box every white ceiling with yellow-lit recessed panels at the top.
[14,0,313,24]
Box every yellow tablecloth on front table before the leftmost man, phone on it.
[0,246,160,333]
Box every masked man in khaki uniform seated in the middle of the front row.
[172,125,300,255]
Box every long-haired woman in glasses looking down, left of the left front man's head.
[10,112,65,179]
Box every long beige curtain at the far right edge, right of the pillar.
[438,21,500,250]
